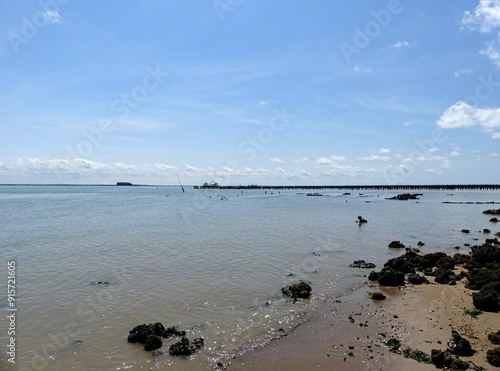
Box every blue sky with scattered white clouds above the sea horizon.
[0,0,500,185]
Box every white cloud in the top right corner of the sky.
[462,0,500,32]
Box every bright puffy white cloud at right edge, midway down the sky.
[437,101,500,139]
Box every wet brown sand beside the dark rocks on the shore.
[229,277,500,371]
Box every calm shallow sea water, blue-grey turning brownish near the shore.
[0,186,500,370]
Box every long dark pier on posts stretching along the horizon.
[193,184,500,191]
